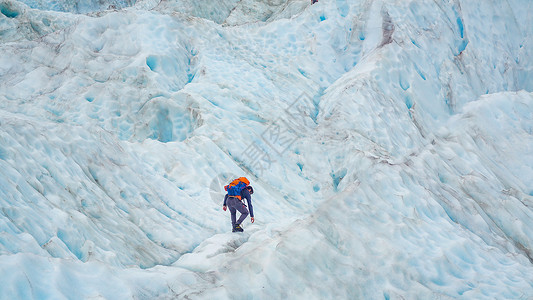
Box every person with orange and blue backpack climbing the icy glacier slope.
[222,177,255,232]
